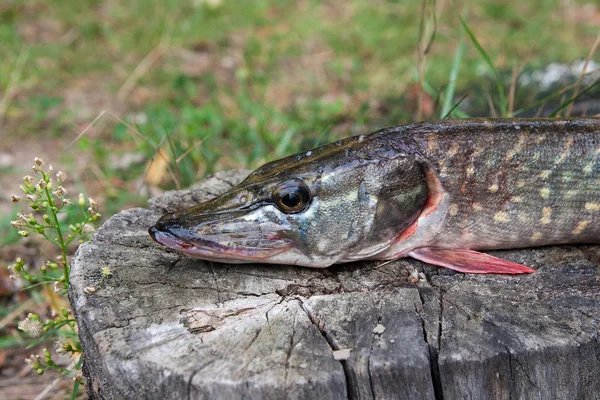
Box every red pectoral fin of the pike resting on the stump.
[408,247,535,274]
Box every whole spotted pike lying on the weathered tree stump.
[149,118,600,274]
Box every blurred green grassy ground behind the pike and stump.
[0,0,600,398]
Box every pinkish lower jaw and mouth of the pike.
[148,221,293,264]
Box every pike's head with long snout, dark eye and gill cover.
[149,135,427,267]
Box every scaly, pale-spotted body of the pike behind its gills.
[415,119,600,250]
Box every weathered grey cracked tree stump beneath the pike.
[70,171,600,400]
